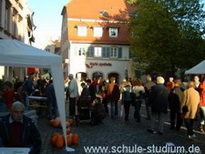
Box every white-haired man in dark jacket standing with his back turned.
[147,76,169,135]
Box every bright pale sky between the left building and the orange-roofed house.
[28,0,70,49]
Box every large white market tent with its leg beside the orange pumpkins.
[0,39,72,151]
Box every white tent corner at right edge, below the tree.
[185,60,205,74]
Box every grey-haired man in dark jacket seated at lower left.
[0,101,42,154]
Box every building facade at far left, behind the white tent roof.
[0,0,34,80]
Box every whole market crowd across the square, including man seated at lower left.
[0,74,205,151]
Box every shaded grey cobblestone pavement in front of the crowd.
[38,102,205,154]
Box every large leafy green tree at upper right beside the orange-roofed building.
[129,0,205,73]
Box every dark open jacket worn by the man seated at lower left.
[0,115,42,154]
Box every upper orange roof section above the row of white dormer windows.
[66,0,135,20]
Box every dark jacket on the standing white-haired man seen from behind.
[149,84,169,113]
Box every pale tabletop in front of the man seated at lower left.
[0,147,30,154]
